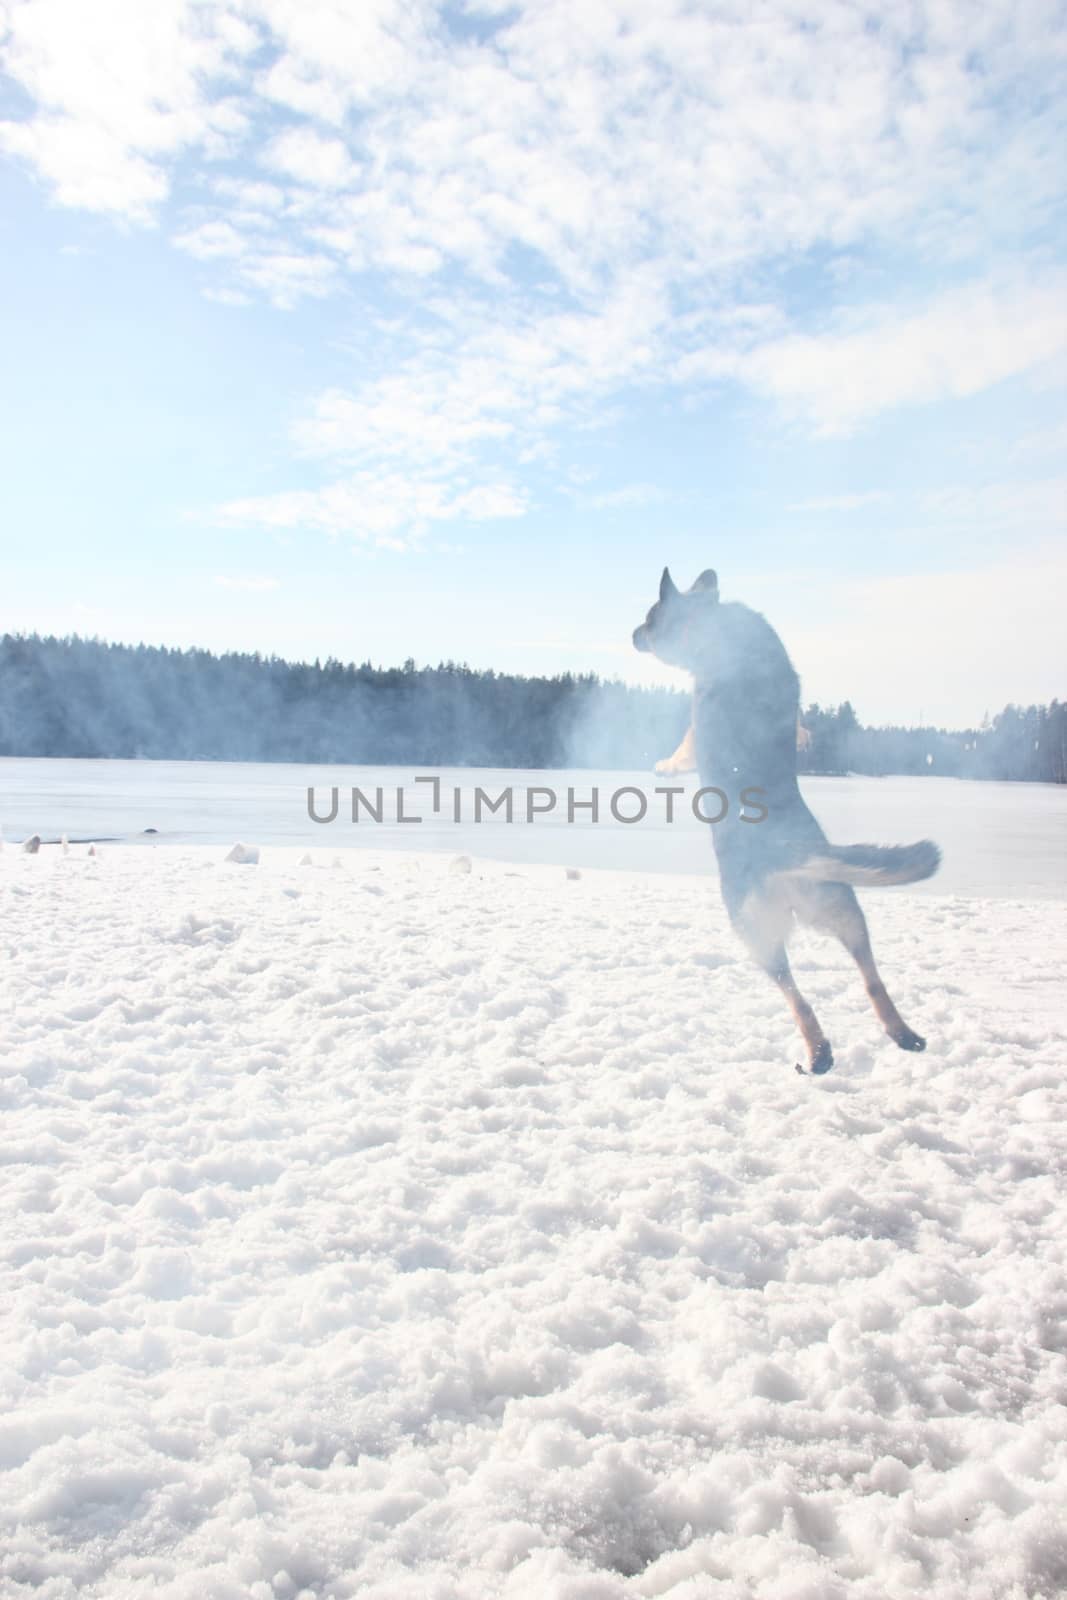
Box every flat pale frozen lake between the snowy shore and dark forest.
[0,758,1067,899]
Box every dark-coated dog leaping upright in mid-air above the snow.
[633,568,941,1074]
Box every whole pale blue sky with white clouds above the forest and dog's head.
[0,0,1067,726]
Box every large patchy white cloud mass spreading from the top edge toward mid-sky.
[0,0,1067,536]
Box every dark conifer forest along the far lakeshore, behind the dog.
[0,634,1067,782]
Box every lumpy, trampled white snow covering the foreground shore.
[0,845,1067,1600]
